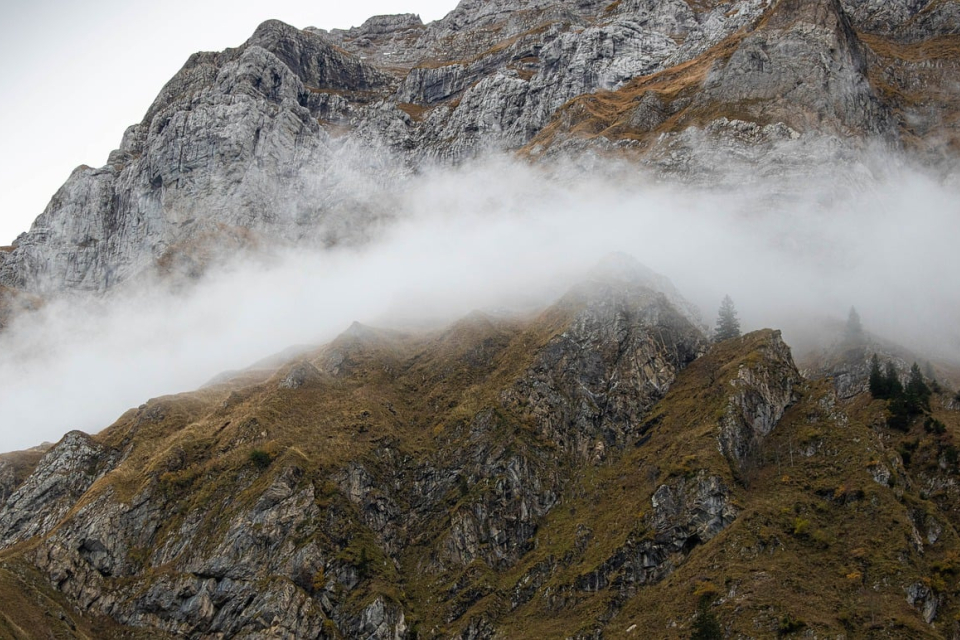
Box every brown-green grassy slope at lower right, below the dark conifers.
[424,336,960,638]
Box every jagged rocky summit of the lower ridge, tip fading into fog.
[503,283,706,457]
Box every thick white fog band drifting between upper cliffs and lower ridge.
[0,152,960,451]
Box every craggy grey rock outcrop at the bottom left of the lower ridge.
[33,467,334,638]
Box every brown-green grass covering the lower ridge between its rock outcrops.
[0,314,960,638]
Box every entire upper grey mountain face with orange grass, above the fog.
[0,0,960,294]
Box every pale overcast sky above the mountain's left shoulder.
[0,0,457,245]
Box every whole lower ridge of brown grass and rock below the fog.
[0,258,960,639]
